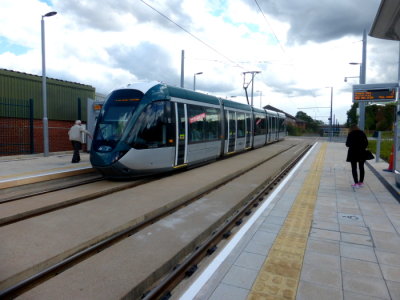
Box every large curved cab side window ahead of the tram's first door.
[131,101,174,149]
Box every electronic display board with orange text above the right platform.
[353,84,398,102]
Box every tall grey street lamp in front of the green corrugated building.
[41,11,57,156]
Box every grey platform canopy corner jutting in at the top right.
[369,0,400,41]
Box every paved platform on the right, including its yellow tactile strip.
[179,142,400,300]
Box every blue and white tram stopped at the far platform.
[90,82,285,178]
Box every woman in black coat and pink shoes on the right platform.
[346,125,368,188]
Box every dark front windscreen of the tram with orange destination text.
[94,90,143,147]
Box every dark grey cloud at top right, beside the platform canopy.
[245,0,380,44]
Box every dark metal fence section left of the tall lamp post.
[0,98,35,156]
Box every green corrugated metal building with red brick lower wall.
[0,69,95,155]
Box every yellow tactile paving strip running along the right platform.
[247,143,327,300]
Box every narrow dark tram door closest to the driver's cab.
[175,103,187,167]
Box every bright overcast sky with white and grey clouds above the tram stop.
[0,0,399,123]
